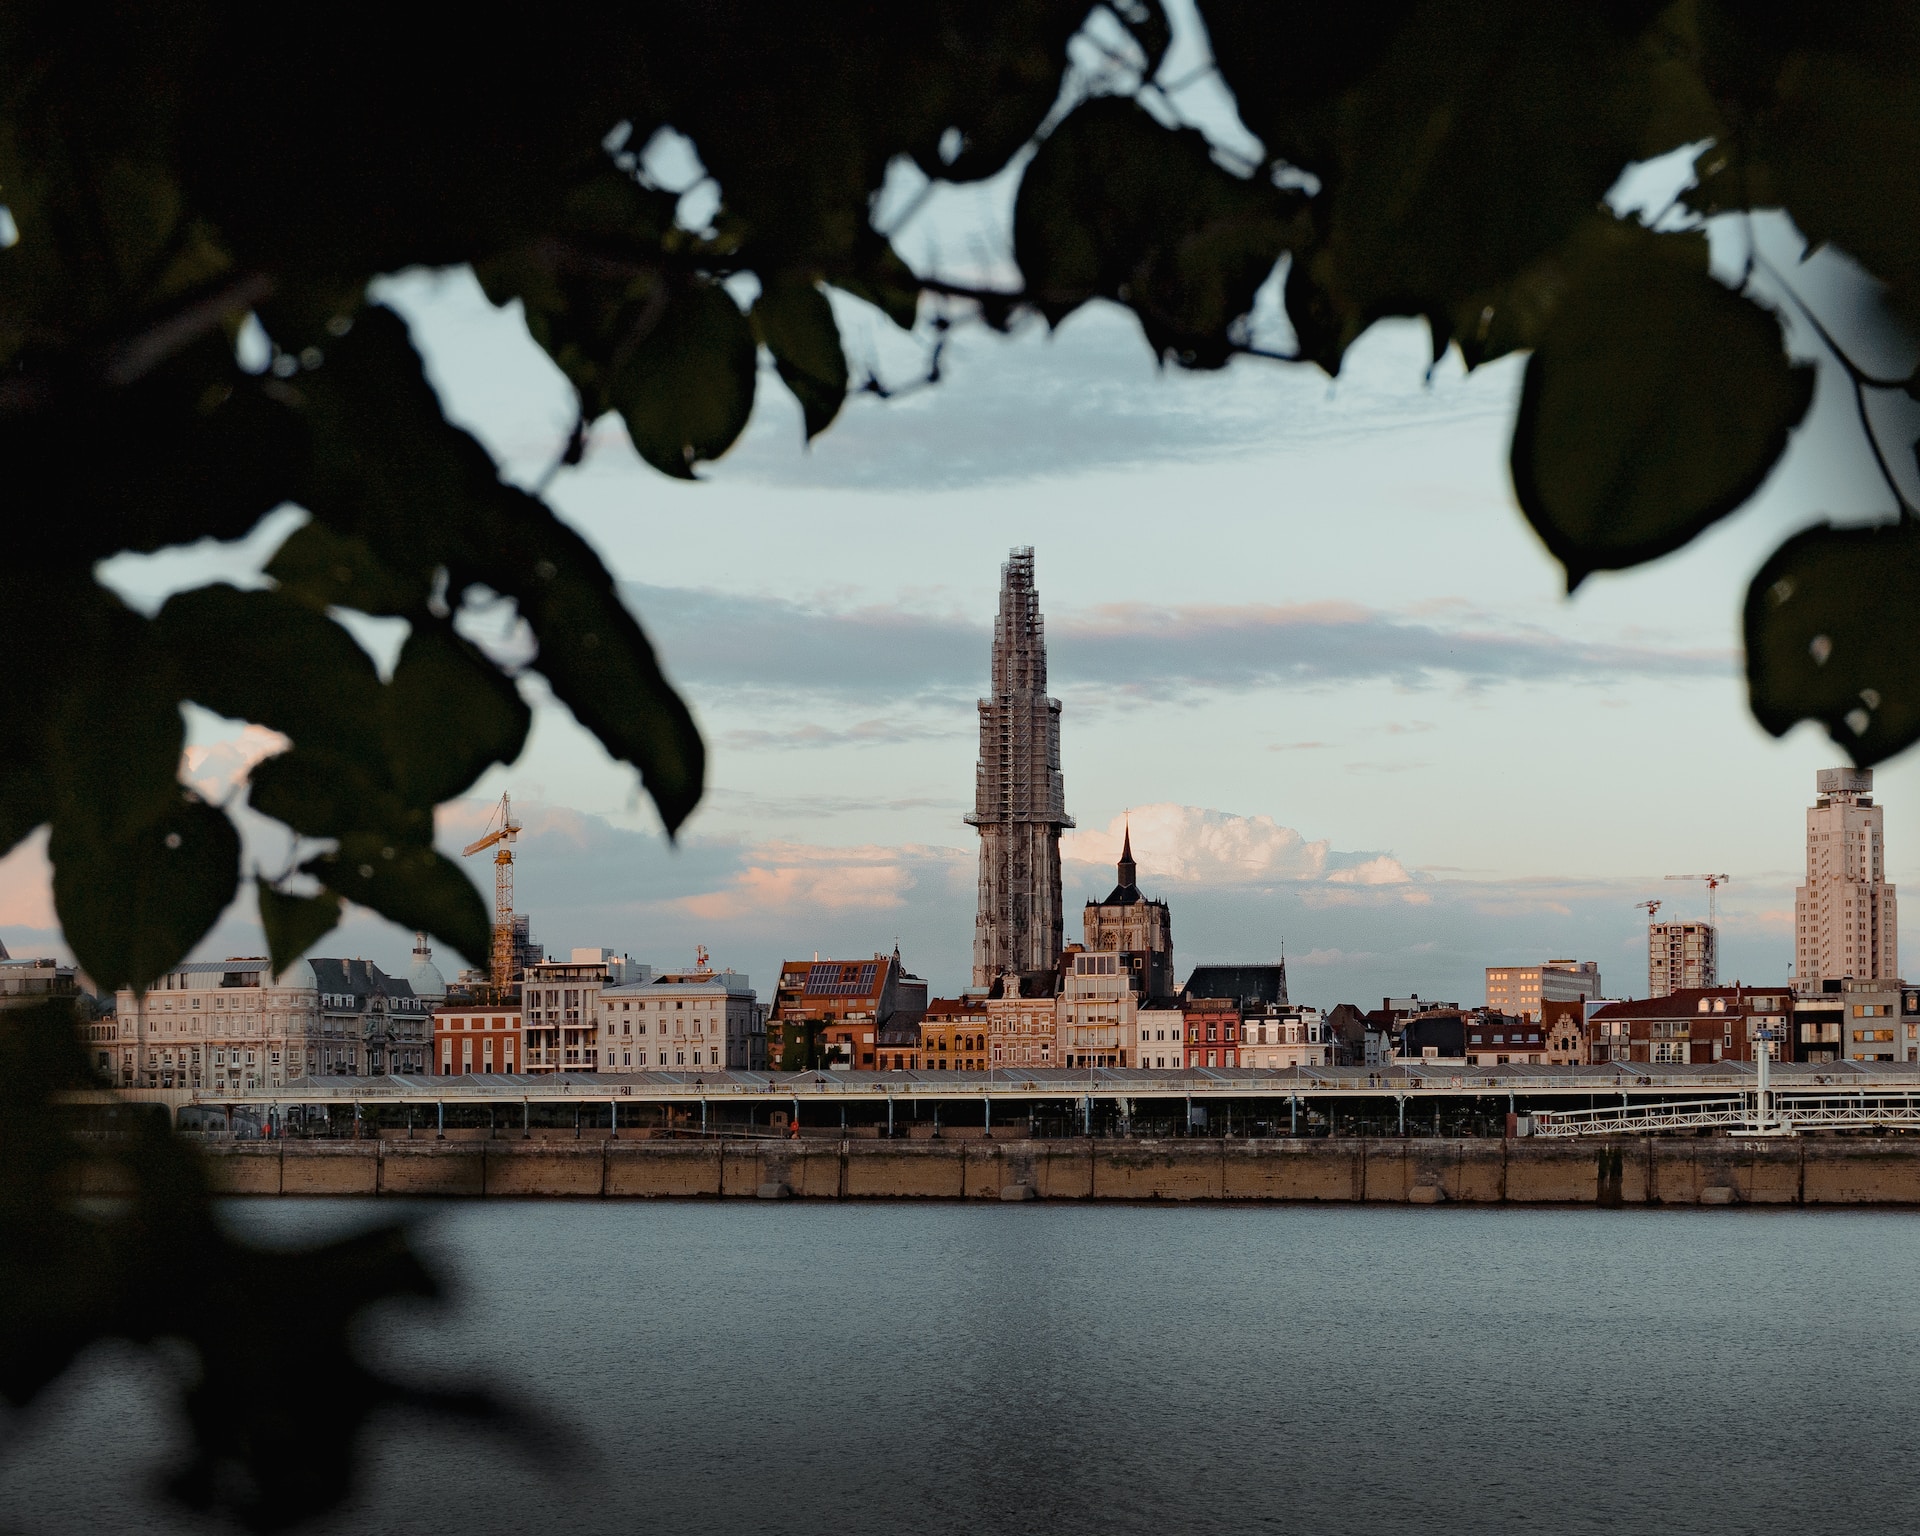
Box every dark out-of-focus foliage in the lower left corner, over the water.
[0,1002,529,1530]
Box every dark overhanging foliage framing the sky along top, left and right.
[0,0,1920,1503]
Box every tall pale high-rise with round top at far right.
[1793,768,1901,993]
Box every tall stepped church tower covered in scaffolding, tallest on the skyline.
[968,549,1073,987]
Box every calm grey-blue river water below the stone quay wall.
[0,1202,1920,1536]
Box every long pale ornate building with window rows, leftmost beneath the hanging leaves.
[113,958,318,1092]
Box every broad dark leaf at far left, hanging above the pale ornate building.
[48,793,240,991]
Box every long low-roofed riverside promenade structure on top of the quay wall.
[77,1062,1920,1139]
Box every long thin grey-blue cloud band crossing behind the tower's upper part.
[622,582,1734,706]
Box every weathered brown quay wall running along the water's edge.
[139,1137,1920,1206]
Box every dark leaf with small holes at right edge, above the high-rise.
[1745,522,1920,768]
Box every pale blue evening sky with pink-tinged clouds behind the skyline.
[0,33,1920,1006]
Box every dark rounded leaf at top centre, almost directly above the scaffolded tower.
[1014,96,1300,367]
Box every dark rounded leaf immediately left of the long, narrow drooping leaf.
[380,616,532,806]
